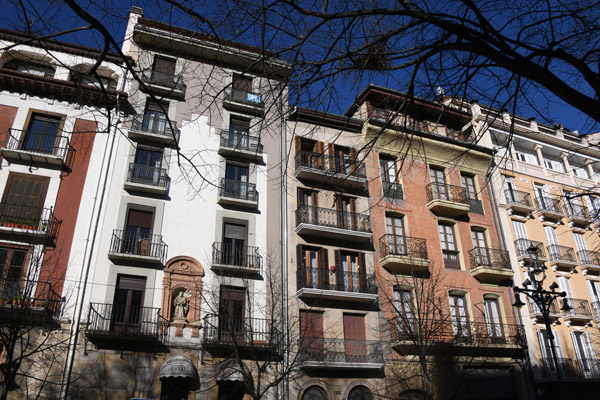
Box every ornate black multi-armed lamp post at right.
[513,245,571,398]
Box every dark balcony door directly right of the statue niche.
[219,286,246,344]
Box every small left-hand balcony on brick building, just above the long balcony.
[379,234,429,275]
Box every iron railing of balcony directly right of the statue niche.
[203,311,281,347]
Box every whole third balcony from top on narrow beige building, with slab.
[296,267,378,304]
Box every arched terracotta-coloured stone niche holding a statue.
[161,256,204,338]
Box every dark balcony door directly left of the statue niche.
[111,275,146,334]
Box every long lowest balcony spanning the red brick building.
[390,316,525,357]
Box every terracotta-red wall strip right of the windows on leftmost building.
[40,119,97,294]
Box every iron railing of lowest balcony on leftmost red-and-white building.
[0,279,62,317]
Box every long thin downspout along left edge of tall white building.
[60,71,128,400]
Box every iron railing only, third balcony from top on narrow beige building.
[296,266,377,294]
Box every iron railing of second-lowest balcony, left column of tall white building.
[110,229,167,262]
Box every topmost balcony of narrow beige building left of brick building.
[295,151,367,189]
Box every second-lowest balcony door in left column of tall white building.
[122,209,154,255]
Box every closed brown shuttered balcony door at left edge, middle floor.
[0,173,50,230]
